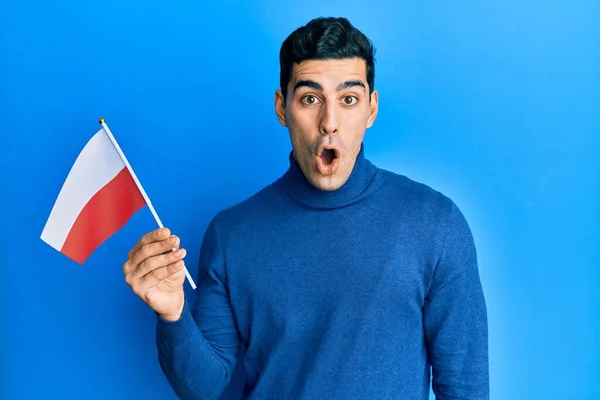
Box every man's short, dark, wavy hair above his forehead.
[279,17,375,101]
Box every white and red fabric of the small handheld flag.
[41,128,147,264]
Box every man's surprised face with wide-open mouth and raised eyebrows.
[275,58,378,191]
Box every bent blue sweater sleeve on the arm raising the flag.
[156,219,240,400]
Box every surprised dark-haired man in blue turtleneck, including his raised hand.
[123,18,489,400]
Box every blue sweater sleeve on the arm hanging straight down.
[423,203,489,400]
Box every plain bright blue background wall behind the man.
[0,0,600,399]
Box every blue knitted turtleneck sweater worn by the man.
[157,148,489,400]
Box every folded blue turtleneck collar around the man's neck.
[280,143,376,209]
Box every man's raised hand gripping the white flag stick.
[123,228,186,321]
